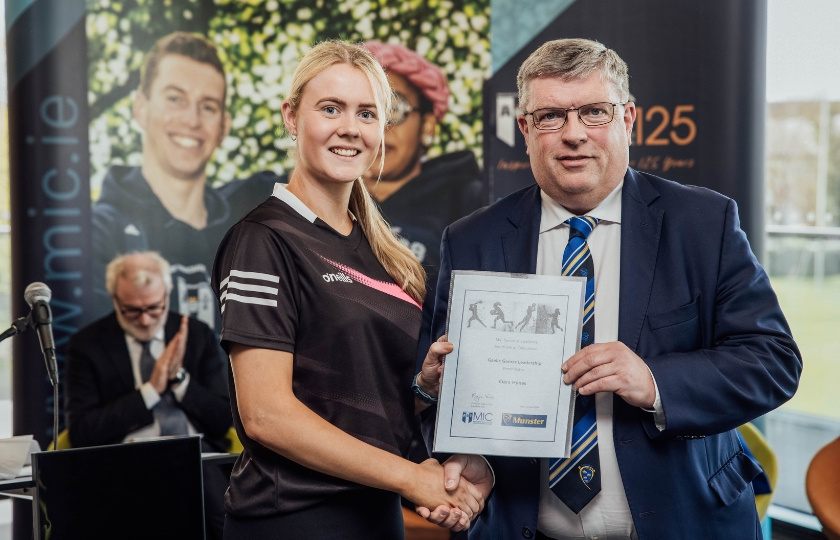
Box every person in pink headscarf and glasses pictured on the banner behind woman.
[362,41,488,304]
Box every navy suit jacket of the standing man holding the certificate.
[423,169,802,540]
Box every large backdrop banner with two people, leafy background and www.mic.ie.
[6,0,490,447]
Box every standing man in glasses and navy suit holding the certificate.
[417,39,802,540]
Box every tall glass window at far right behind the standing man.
[763,0,840,515]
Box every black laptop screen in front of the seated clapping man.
[32,437,204,540]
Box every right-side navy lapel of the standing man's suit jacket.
[618,169,663,350]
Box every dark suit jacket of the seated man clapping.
[64,312,233,452]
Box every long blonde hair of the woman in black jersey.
[286,40,426,304]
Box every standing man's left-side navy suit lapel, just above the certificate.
[502,185,542,274]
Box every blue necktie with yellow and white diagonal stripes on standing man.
[548,216,601,514]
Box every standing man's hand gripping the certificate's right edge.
[561,341,656,409]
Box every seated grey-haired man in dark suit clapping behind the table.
[65,252,233,538]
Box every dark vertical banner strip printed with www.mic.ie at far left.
[6,0,91,448]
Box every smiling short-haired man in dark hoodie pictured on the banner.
[92,32,232,329]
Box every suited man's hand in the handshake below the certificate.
[417,454,493,530]
